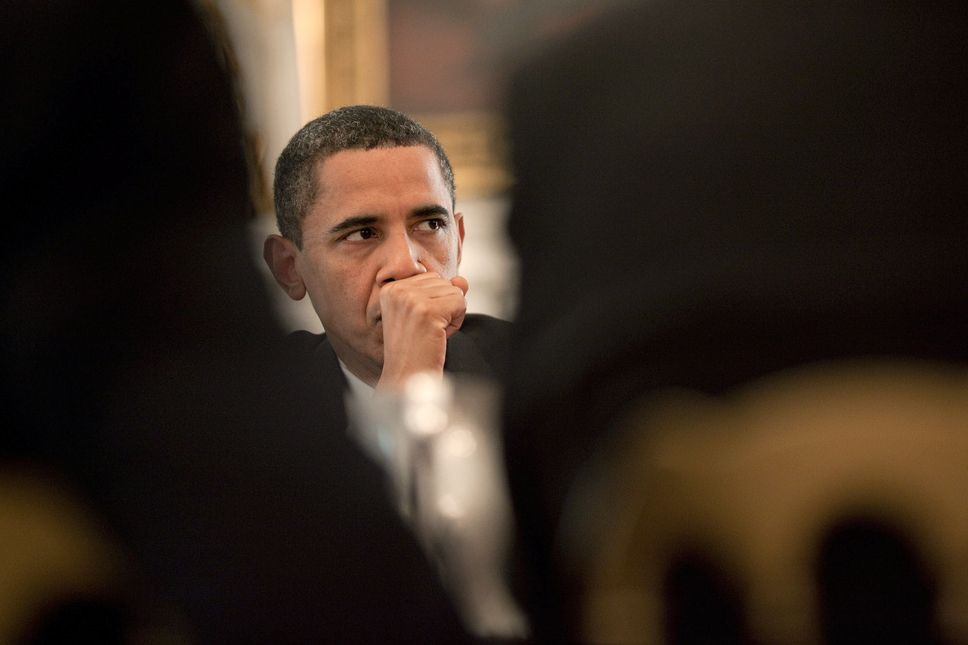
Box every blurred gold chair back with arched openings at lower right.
[558,361,968,643]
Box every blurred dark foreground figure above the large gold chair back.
[505,0,968,636]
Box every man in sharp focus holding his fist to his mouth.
[264,105,510,636]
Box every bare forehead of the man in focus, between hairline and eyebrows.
[313,145,450,210]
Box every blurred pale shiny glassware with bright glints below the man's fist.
[347,374,529,638]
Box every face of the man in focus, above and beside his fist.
[295,145,464,378]
